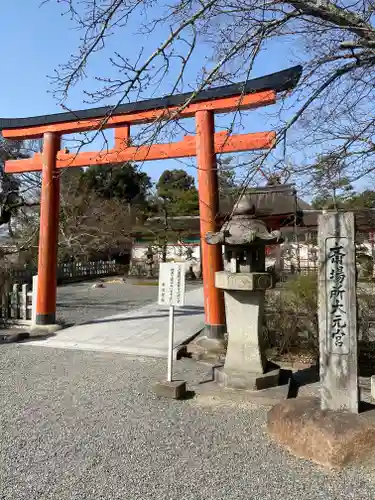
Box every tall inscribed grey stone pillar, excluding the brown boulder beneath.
[319,212,359,413]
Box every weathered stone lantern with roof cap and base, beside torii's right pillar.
[206,197,282,390]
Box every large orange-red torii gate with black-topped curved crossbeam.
[0,66,302,338]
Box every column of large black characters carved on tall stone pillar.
[326,238,349,354]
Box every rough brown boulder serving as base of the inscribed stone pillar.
[267,398,375,468]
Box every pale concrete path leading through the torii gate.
[27,288,204,358]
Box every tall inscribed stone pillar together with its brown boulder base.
[268,212,375,468]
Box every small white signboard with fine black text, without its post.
[158,263,185,307]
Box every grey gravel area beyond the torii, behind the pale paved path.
[57,280,199,325]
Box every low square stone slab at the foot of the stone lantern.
[215,367,281,391]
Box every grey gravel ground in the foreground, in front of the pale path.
[0,345,375,500]
